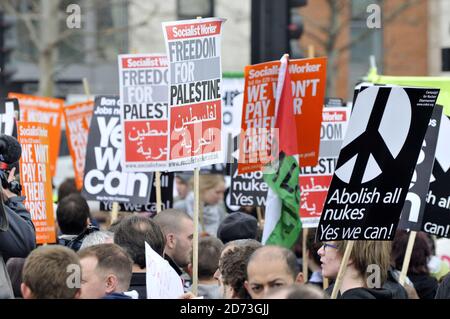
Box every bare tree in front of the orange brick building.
[302,0,424,96]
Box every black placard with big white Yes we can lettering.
[82,96,153,204]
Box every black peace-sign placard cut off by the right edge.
[422,115,450,238]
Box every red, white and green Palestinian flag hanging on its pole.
[262,55,302,248]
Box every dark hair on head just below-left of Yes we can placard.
[56,194,90,235]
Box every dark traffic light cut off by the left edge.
[0,11,14,97]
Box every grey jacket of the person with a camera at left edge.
[0,197,36,299]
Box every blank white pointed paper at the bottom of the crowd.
[145,243,184,299]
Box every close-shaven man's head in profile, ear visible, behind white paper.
[154,209,194,268]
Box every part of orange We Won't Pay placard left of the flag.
[238,61,280,174]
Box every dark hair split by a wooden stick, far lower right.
[391,230,431,275]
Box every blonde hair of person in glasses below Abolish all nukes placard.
[336,240,391,284]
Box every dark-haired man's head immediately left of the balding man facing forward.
[214,239,261,299]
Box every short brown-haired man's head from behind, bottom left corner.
[21,246,81,299]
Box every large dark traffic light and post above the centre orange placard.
[251,0,307,64]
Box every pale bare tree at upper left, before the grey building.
[0,0,158,96]
